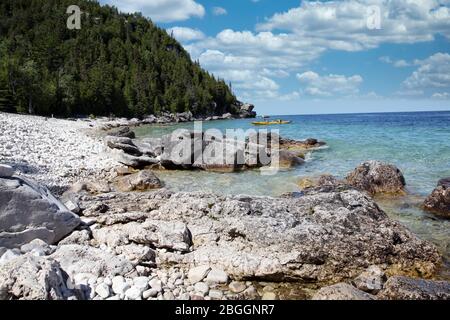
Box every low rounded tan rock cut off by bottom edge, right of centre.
[312,283,375,300]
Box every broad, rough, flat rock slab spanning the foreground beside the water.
[77,189,441,284]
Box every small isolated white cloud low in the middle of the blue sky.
[297,71,363,97]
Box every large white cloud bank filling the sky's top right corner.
[258,0,450,51]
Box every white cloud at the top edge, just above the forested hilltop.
[103,0,205,22]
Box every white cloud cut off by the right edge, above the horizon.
[403,53,450,97]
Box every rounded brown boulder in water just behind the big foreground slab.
[346,161,406,195]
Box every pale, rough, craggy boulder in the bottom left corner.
[0,254,74,300]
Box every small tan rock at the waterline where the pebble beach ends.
[116,170,162,192]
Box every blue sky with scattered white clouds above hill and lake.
[100,0,450,114]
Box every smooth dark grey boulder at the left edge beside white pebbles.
[0,177,80,248]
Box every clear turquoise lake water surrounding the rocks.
[136,112,450,273]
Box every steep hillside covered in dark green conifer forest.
[0,0,237,117]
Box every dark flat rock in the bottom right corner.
[379,276,450,300]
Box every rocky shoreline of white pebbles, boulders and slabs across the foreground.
[0,114,450,300]
